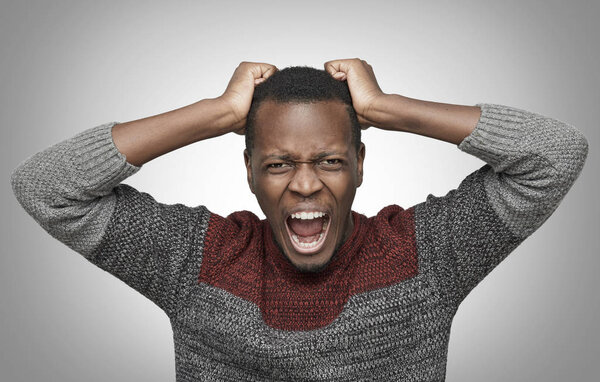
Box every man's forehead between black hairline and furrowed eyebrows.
[254,101,352,158]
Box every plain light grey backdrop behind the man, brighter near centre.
[0,1,600,382]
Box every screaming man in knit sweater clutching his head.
[11,59,588,381]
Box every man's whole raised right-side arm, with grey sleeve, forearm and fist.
[326,60,588,306]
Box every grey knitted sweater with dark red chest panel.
[11,104,588,381]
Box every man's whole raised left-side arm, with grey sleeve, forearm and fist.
[11,63,274,315]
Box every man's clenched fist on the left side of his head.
[218,61,278,135]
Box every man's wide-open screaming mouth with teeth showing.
[285,211,330,254]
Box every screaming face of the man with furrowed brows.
[244,101,365,272]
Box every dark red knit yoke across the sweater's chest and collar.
[199,206,418,330]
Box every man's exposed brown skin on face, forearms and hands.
[112,58,481,271]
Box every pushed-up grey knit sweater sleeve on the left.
[11,122,208,316]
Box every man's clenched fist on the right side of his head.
[325,58,386,130]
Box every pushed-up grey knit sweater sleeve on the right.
[415,104,588,306]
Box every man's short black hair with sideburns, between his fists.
[246,66,361,153]
